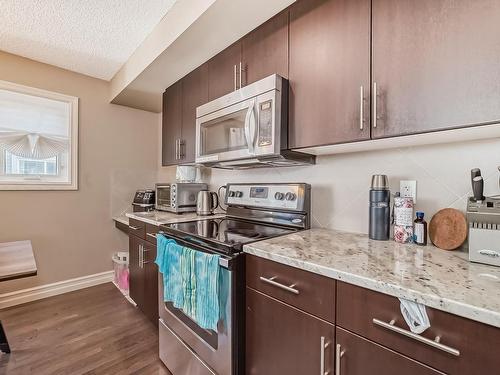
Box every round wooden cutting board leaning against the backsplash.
[429,208,467,250]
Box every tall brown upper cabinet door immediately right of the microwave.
[289,0,370,148]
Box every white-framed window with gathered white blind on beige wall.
[0,81,78,190]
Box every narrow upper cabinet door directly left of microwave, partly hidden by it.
[181,63,208,163]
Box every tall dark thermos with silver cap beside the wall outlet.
[368,174,391,241]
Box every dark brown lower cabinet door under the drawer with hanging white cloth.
[335,327,444,375]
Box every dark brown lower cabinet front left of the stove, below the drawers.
[129,235,158,325]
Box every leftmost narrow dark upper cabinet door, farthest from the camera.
[161,81,182,165]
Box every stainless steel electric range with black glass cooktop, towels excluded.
[159,183,311,375]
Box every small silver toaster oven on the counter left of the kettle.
[155,182,208,214]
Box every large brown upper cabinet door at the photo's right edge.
[372,0,500,138]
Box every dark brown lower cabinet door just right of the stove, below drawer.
[245,288,335,375]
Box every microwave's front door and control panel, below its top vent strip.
[196,90,281,164]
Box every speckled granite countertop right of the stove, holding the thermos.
[243,229,500,328]
